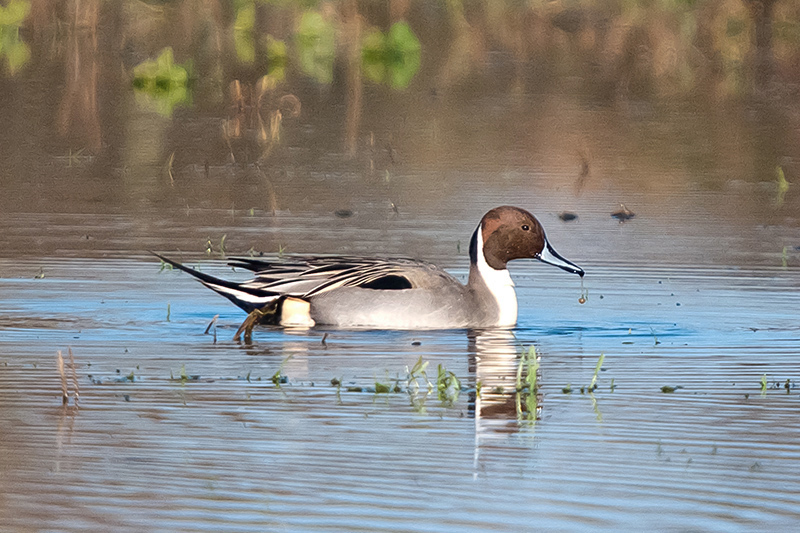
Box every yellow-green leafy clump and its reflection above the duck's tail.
[133,48,189,117]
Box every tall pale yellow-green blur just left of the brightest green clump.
[295,11,336,83]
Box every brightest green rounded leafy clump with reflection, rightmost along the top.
[362,22,421,89]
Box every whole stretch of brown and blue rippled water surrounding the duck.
[0,2,800,532]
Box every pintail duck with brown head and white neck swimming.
[156,206,584,329]
